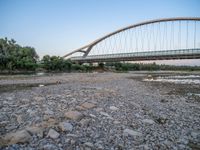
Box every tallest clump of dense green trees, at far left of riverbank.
[0,38,39,71]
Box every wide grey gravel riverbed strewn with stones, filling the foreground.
[0,73,200,150]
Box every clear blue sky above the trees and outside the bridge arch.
[0,0,200,64]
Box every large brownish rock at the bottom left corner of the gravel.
[1,130,32,145]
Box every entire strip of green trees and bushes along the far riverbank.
[0,38,200,73]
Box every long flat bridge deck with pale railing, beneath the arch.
[70,48,200,63]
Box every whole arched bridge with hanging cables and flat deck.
[63,17,200,62]
